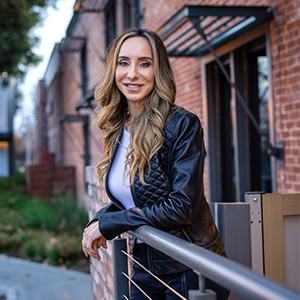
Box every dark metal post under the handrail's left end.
[112,238,129,300]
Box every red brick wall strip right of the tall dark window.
[271,0,300,193]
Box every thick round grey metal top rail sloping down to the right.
[128,225,300,300]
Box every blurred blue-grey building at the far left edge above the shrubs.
[0,76,15,177]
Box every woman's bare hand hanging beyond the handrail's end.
[82,221,107,260]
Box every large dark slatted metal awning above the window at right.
[157,5,273,56]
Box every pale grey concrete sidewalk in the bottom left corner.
[0,255,92,300]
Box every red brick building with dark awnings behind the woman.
[37,0,300,202]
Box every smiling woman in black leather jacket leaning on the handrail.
[82,29,228,300]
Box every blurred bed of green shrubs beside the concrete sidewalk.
[0,173,88,265]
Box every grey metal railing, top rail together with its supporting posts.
[113,225,300,300]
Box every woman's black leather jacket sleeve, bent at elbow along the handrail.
[99,111,205,240]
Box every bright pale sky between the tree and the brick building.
[14,0,75,134]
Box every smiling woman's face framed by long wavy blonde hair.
[115,37,155,105]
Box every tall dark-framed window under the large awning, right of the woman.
[206,36,272,202]
